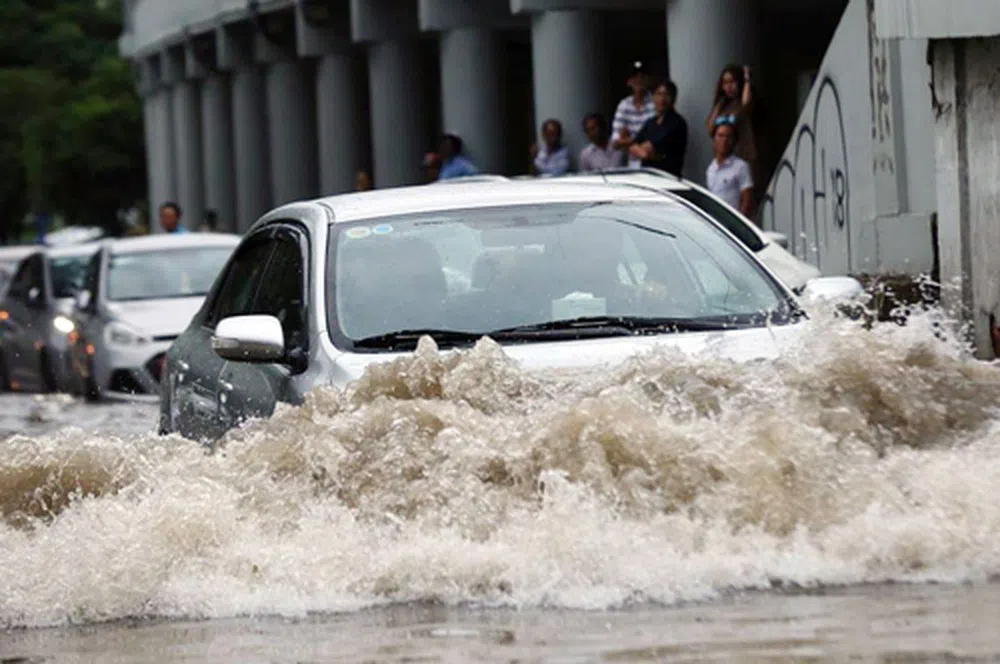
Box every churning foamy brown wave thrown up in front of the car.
[0,308,1000,626]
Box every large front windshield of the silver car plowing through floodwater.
[328,200,798,351]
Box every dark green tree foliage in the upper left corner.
[0,0,146,239]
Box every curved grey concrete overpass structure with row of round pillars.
[121,0,846,230]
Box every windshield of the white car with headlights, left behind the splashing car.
[107,247,232,301]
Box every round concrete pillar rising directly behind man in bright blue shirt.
[441,27,505,173]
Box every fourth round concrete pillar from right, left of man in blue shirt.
[368,39,430,188]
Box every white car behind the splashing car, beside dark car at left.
[72,233,239,401]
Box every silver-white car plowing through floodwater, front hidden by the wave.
[159,180,859,439]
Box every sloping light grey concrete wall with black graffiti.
[761,0,937,274]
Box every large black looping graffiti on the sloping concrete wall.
[761,75,851,274]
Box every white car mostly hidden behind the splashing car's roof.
[472,168,822,293]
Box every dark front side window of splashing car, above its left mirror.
[253,236,308,349]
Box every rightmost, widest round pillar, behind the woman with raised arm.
[667,0,758,183]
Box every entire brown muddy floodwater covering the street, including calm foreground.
[0,314,1000,664]
